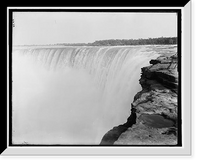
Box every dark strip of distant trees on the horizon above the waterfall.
[57,37,177,46]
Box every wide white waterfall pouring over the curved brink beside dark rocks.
[12,45,176,145]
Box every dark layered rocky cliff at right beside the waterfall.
[100,54,178,145]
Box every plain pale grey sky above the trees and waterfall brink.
[13,12,177,45]
